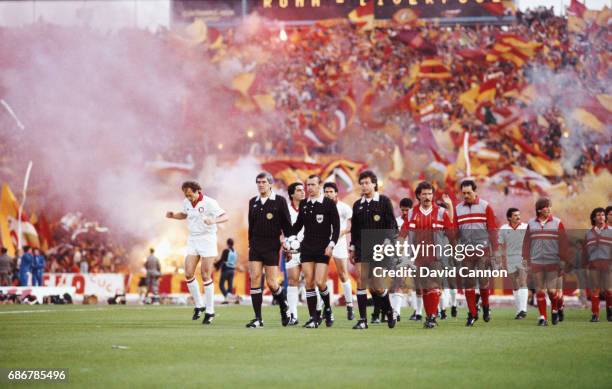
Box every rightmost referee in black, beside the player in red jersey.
[350,170,397,330]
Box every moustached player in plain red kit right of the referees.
[407,182,453,328]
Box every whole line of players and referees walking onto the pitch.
[166,171,612,329]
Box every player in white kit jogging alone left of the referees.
[166,181,228,324]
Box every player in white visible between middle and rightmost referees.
[323,182,355,320]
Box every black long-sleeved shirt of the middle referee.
[293,195,340,253]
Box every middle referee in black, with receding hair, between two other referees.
[293,175,340,328]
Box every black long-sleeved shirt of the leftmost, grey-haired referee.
[249,192,292,251]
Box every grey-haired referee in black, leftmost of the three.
[246,172,291,328]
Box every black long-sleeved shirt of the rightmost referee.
[351,192,397,253]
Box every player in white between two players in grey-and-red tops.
[499,208,529,320]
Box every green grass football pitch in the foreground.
[0,305,612,388]
